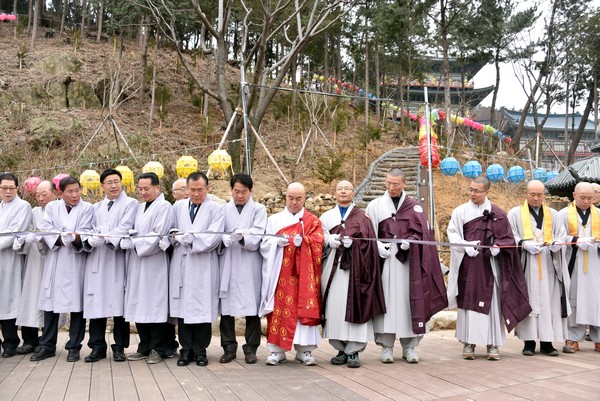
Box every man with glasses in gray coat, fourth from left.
[83,169,138,362]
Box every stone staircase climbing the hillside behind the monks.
[354,146,420,208]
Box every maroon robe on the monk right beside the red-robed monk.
[323,207,385,324]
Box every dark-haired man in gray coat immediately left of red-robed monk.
[219,173,267,364]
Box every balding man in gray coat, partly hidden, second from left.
[15,181,56,354]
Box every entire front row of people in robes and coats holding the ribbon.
[0,168,600,368]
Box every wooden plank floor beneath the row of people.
[0,331,600,401]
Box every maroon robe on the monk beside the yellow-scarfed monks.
[457,205,531,332]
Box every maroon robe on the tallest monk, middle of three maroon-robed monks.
[378,197,448,334]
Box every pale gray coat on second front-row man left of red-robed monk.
[169,197,223,324]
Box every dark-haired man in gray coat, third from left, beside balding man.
[30,176,93,362]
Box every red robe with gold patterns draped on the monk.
[267,209,323,350]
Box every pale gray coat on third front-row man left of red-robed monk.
[124,194,173,323]
